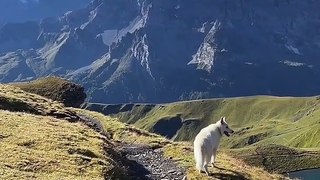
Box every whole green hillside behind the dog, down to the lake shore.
[86,96,320,172]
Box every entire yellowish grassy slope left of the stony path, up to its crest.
[0,85,127,179]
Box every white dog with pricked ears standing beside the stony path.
[193,117,234,175]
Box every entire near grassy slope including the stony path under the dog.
[0,85,282,179]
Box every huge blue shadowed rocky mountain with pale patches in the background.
[0,0,320,103]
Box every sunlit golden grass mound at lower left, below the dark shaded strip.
[0,110,125,179]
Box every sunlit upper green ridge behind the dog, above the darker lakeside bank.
[102,96,320,148]
